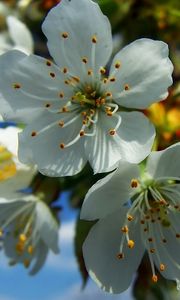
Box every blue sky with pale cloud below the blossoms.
[0,194,133,300]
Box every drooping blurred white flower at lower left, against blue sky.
[0,195,59,275]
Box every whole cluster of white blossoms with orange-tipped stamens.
[0,0,180,293]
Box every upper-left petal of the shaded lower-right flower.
[81,162,139,220]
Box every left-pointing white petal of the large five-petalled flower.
[0,50,72,123]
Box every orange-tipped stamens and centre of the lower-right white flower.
[117,178,180,282]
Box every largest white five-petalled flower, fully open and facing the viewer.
[0,0,173,176]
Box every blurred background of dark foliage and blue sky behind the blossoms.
[0,0,180,300]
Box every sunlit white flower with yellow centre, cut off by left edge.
[0,126,36,199]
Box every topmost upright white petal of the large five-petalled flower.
[42,0,112,76]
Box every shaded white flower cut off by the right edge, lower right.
[81,143,180,293]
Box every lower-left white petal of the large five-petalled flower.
[19,111,86,176]
